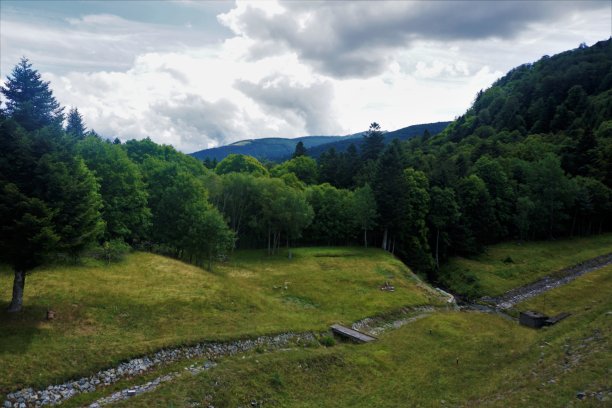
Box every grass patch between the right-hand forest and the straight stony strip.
[440,234,612,297]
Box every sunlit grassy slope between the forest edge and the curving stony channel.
[0,248,438,392]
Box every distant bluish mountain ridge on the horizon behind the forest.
[190,122,451,161]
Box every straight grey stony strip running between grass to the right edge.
[480,253,612,310]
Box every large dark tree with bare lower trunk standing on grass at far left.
[0,119,103,312]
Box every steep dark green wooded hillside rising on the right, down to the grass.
[404,39,612,255]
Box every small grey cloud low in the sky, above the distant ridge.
[235,76,340,134]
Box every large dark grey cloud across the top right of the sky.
[220,1,610,77]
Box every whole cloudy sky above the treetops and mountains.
[0,0,612,152]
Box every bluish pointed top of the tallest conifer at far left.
[0,57,63,130]
